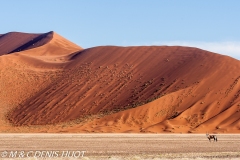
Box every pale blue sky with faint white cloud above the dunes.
[0,0,240,59]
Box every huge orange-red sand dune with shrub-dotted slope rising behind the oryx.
[0,32,240,133]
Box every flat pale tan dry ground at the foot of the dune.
[0,134,240,159]
